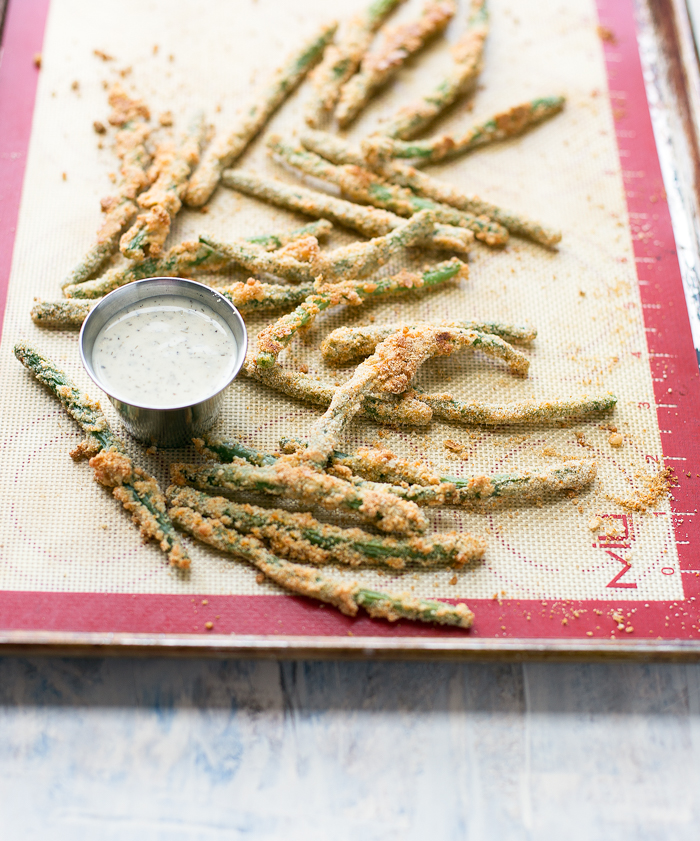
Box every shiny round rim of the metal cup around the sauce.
[78,277,248,412]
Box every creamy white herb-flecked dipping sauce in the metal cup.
[92,295,238,409]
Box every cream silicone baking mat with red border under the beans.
[0,0,700,650]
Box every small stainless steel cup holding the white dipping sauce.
[80,277,248,447]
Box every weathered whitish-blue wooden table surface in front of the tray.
[0,657,700,841]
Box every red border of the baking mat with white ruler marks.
[0,0,700,642]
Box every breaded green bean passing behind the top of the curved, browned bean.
[321,321,537,365]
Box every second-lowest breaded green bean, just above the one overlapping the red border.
[166,485,485,569]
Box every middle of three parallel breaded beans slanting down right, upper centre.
[268,135,508,245]
